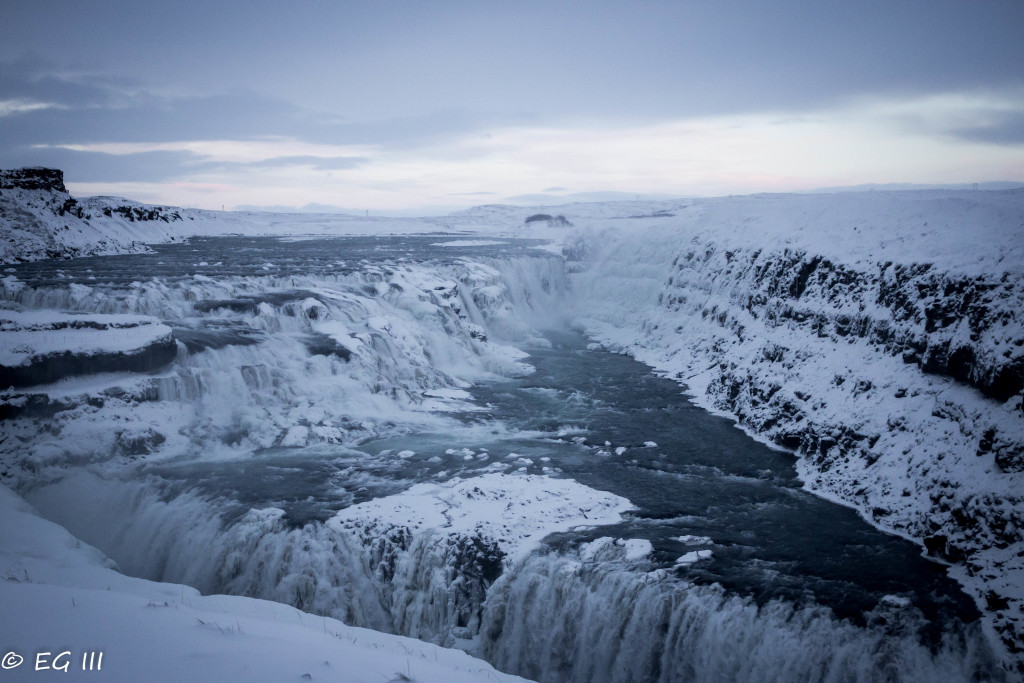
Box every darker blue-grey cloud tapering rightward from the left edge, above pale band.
[0,61,520,156]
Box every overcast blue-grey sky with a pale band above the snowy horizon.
[0,0,1024,214]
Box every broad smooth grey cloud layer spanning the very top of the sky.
[6,0,1024,127]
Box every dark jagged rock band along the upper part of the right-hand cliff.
[663,249,1024,401]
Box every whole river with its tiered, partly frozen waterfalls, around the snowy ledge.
[4,238,998,681]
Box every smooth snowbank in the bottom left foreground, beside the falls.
[0,486,523,683]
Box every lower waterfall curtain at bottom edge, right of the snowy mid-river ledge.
[478,554,998,683]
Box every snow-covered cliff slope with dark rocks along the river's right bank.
[567,190,1024,663]
